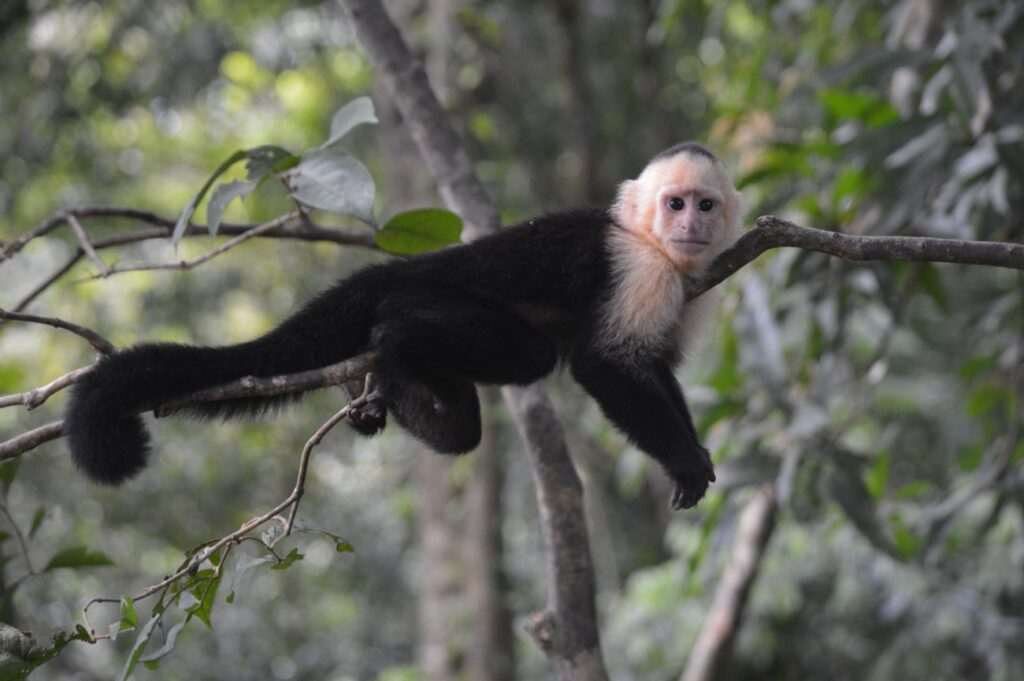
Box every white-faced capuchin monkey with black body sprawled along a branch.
[65,142,743,510]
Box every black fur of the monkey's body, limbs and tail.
[65,201,714,506]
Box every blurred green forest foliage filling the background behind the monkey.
[0,0,1024,681]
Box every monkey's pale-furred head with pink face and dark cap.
[612,142,745,273]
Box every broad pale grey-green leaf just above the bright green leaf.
[289,147,376,225]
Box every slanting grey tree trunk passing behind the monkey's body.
[340,0,607,681]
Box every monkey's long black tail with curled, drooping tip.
[63,280,373,484]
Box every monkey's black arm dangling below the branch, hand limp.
[572,348,715,510]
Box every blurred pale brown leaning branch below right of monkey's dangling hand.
[682,484,777,681]
